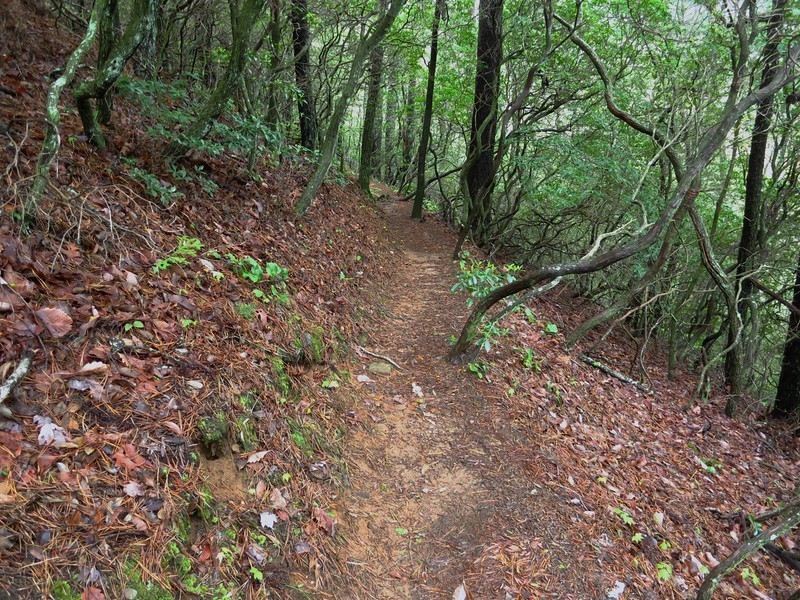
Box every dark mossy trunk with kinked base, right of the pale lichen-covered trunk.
[75,0,156,148]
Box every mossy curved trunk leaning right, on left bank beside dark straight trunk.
[164,0,266,159]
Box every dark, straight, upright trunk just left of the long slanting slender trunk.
[291,0,317,150]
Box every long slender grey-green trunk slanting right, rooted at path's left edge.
[294,0,405,215]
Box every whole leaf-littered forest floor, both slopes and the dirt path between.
[0,0,800,600]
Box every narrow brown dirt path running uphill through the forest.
[324,201,592,599]
